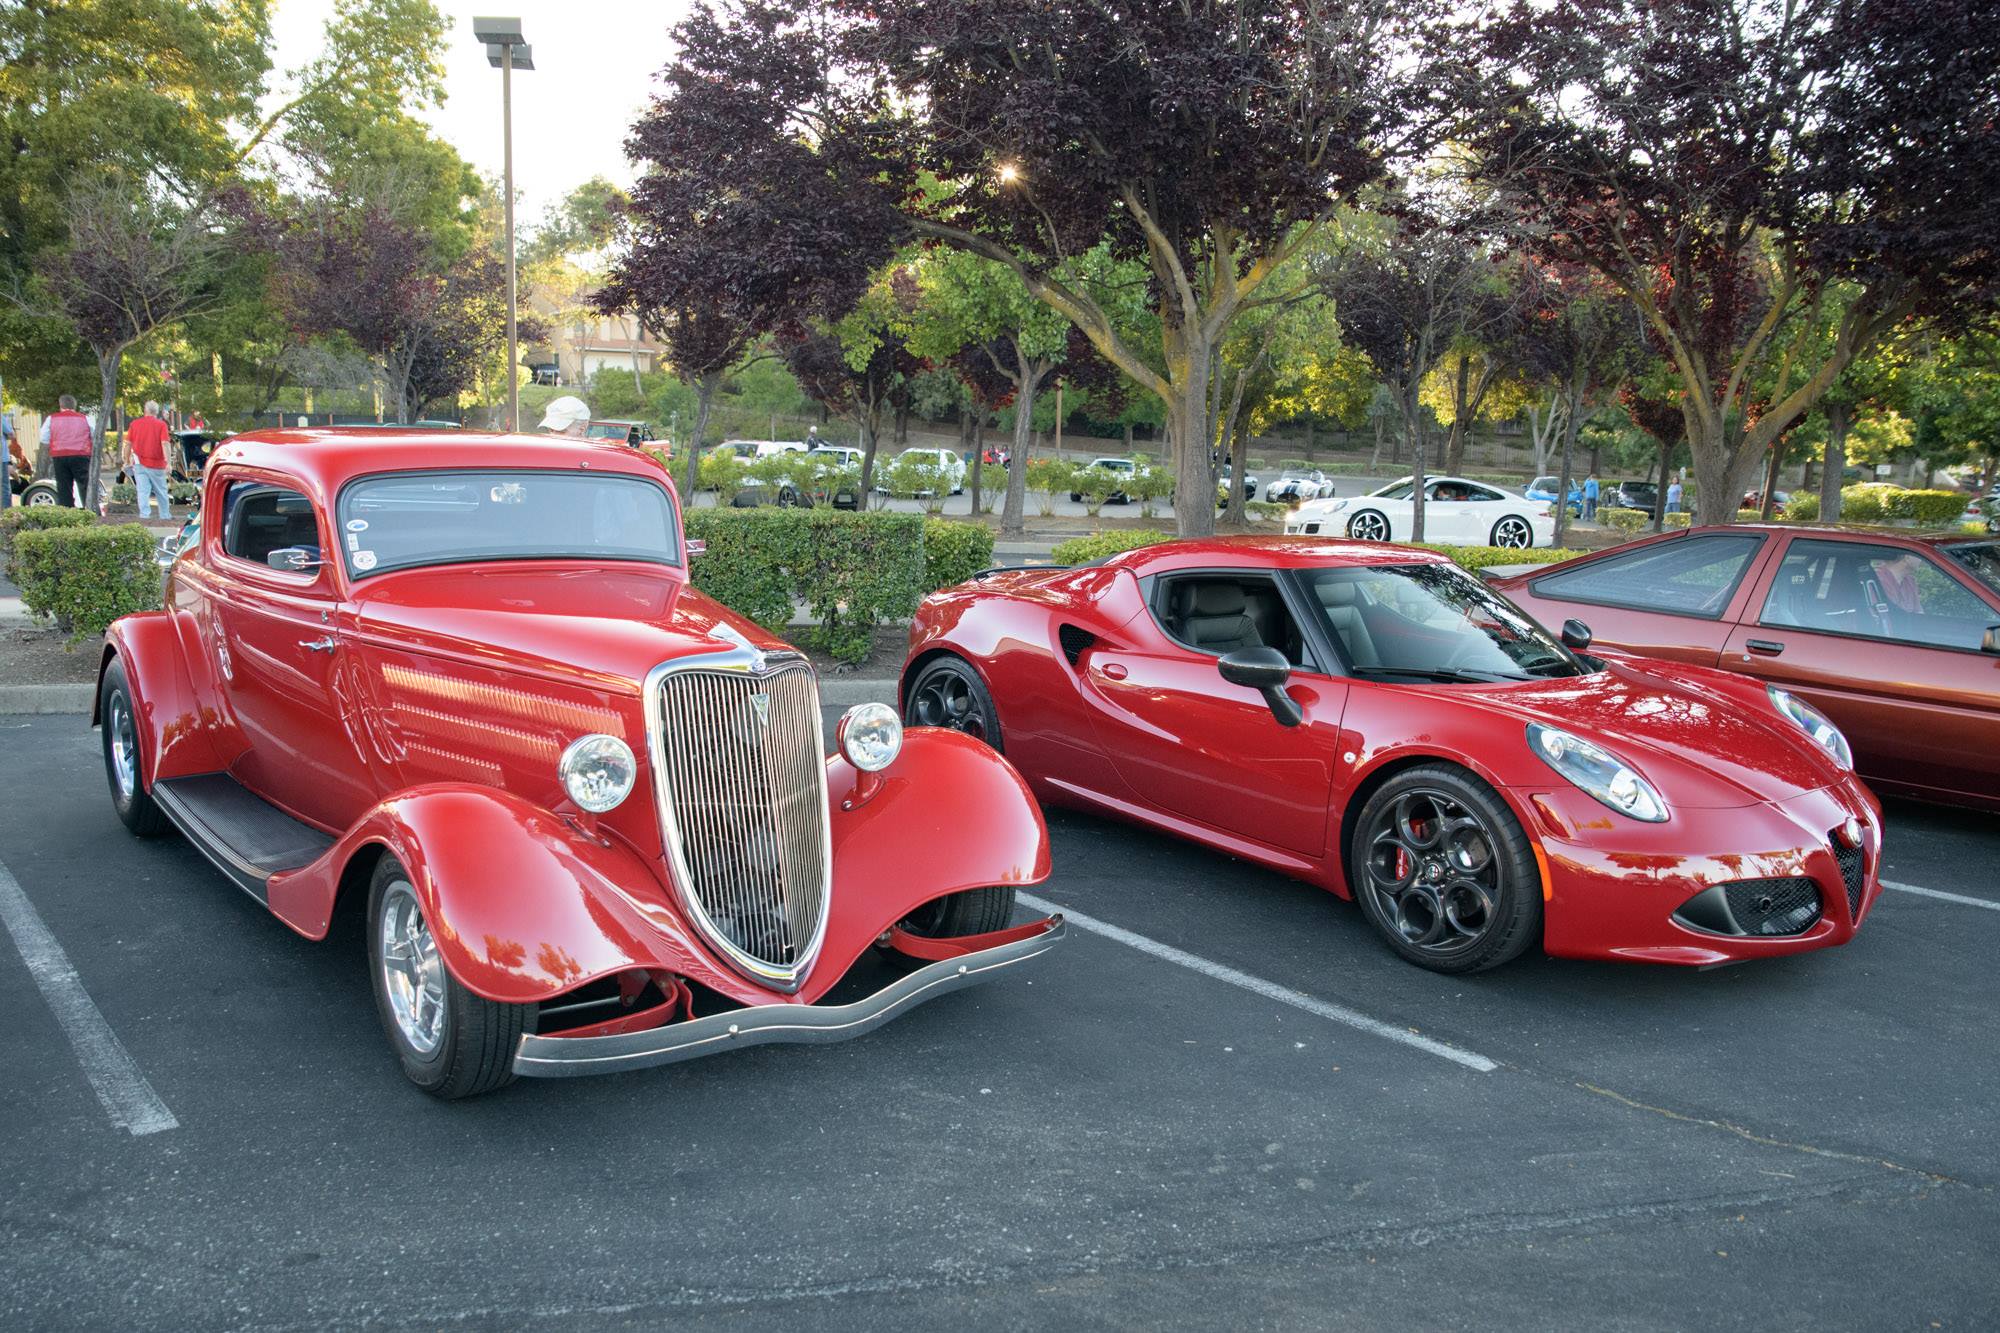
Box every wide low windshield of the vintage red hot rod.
[340,470,680,578]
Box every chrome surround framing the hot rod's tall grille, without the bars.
[642,644,834,993]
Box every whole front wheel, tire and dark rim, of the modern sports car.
[1346,763,1542,975]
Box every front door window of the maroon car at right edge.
[1758,538,1994,652]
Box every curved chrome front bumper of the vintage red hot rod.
[514,915,1066,1079]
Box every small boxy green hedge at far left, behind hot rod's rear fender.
[14,522,160,644]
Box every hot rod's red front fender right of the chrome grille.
[800,727,1048,1003]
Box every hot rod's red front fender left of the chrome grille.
[268,783,728,1005]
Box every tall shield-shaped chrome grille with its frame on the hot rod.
[652,654,828,989]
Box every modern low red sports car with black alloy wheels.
[902,536,1882,973]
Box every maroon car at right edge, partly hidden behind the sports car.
[1492,524,2000,811]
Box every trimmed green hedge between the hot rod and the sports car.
[688,508,994,662]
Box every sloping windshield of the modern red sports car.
[1304,564,1584,681]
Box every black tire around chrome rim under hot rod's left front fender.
[368,855,536,1101]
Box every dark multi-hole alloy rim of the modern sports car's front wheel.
[1362,787,1502,959]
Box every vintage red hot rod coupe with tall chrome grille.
[96,430,1062,1097]
